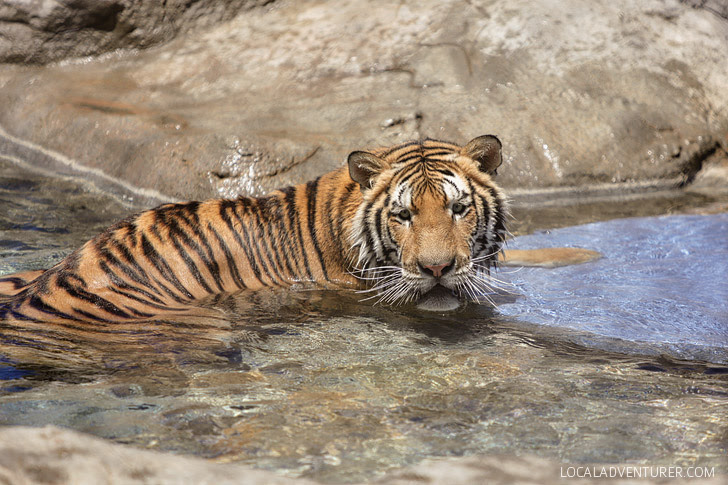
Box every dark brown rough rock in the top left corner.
[0,0,267,64]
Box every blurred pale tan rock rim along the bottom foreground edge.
[0,426,725,485]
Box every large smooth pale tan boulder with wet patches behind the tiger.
[0,0,728,203]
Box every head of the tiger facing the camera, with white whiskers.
[348,135,507,304]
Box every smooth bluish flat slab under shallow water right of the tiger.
[498,214,728,362]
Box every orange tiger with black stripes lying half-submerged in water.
[0,135,509,328]
